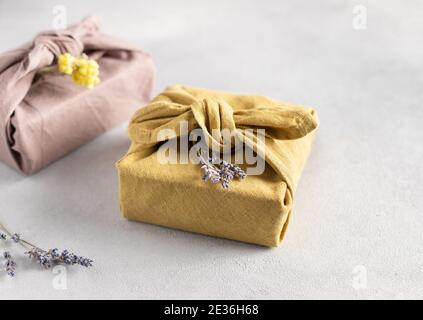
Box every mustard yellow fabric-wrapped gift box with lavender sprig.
[117,85,318,246]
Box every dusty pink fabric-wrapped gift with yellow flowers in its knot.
[0,17,154,174]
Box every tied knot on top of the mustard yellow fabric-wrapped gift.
[129,85,317,148]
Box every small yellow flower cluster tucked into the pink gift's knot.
[58,53,100,88]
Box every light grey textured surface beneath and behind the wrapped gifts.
[0,0,423,299]
